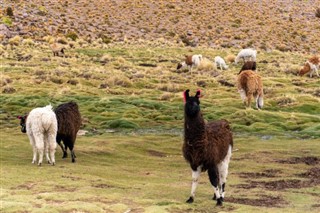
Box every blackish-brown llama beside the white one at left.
[54,101,81,163]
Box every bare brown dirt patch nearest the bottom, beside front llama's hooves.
[226,195,288,208]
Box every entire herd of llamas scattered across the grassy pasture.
[18,46,320,208]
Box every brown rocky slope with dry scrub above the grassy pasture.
[0,0,320,54]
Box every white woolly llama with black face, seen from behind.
[18,105,58,166]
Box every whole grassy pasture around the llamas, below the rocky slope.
[0,42,320,213]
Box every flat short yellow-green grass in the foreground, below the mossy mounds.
[0,129,320,212]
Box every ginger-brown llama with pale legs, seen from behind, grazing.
[237,70,263,110]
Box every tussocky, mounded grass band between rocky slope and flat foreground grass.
[1,43,320,137]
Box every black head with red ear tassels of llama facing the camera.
[183,90,201,117]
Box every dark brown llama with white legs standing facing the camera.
[182,90,233,205]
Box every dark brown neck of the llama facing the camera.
[184,113,206,144]
